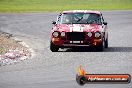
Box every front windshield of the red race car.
[58,13,101,24]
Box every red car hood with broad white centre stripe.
[55,24,102,32]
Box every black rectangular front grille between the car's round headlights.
[67,32,85,41]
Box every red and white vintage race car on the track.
[50,10,108,52]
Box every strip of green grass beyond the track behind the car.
[0,0,132,12]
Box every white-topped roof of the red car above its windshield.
[62,10,101,14]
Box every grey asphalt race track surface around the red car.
[0,11,132,88]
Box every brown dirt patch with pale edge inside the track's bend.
[0,32,31,66]
